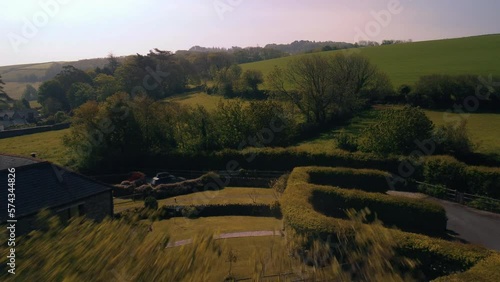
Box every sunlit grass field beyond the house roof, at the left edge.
[0,129,69,165]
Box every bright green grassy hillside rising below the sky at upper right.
[241,35,500,87]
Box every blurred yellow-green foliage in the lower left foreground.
[0,212,224,281]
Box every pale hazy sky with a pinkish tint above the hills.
[0,0,500,66]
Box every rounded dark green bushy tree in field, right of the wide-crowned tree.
[359,106,434,154]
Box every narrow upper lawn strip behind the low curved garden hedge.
[114,187,275,213]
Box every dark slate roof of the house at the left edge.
[0,162,112,222]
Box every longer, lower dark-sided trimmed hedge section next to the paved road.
[311,187,448,235]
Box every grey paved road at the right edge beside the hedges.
[438,200,500,251]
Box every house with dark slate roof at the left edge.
[0,154,113,233]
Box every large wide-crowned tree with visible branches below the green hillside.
[267,54,387,124]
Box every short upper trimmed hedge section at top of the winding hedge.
[309,167,391,193]
